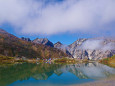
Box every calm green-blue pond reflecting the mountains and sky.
[0,63,115,86]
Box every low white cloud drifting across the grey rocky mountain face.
[79,39,115,51]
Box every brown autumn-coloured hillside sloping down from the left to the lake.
[0,29,68,59]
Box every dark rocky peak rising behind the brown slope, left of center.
[33,38,54,47]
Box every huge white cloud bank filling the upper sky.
[0,0,115,35]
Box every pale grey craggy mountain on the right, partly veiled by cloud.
[54,38,115,60]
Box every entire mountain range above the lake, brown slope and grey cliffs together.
[0,29,115,60]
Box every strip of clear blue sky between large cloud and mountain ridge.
[0,24,93,45]
